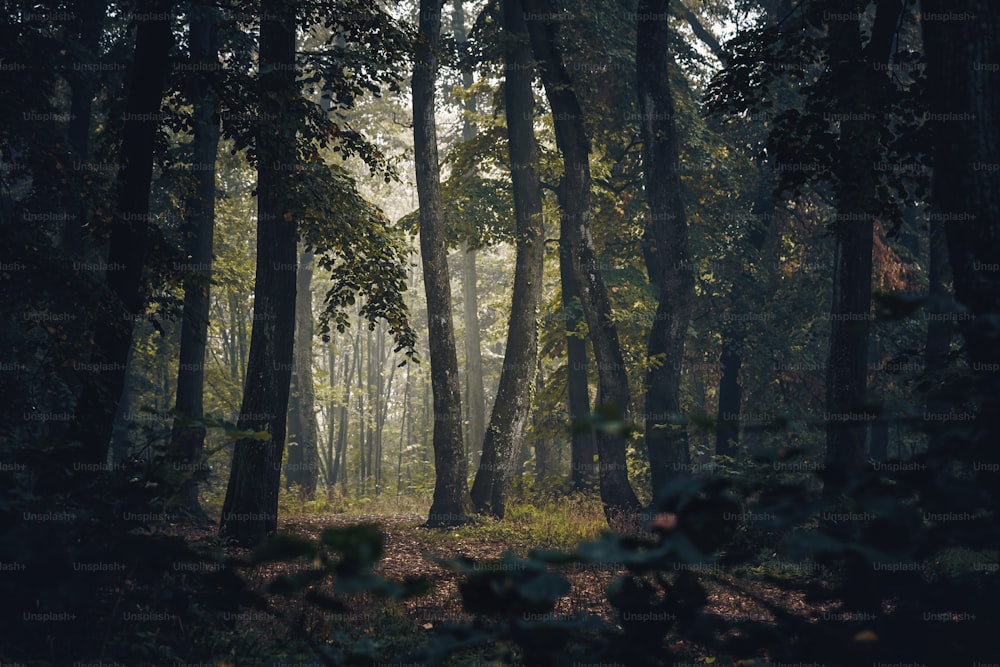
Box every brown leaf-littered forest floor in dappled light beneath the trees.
[172,506,831,659]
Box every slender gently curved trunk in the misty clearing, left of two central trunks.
[411,0,470,526]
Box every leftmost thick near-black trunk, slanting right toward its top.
[70,2,174,464]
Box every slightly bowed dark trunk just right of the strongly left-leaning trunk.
[636,0,694,494]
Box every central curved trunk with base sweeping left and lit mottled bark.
[472,0,545,518]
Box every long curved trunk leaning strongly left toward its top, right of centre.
[521,0,639,522]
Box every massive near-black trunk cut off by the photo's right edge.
[922,0,1000,468]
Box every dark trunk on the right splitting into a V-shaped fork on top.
[824,0,903,496]
